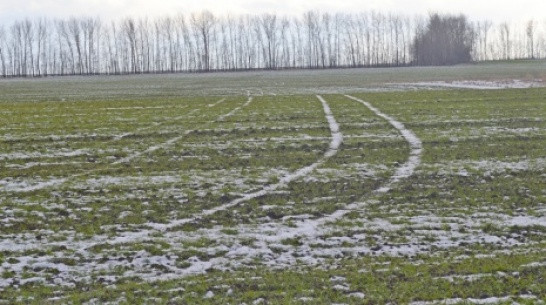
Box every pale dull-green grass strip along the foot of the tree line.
[0,60,546,103]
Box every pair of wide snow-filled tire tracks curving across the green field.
[0,95,423,281]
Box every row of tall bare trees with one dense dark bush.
[0,11,546,77]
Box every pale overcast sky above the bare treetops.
[0,0,546,24]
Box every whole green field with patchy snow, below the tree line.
[0,61,546,304]
